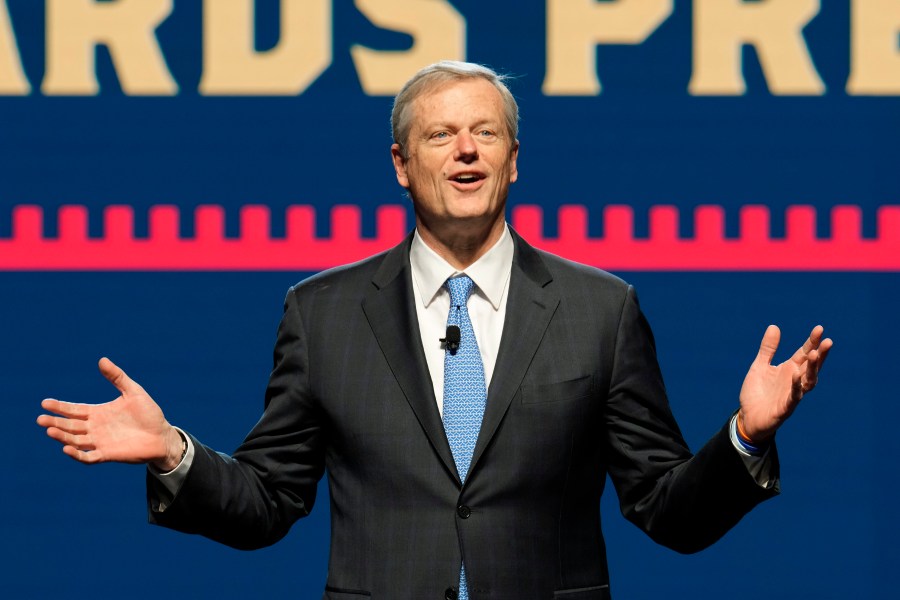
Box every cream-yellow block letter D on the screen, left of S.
[200,0,331,96]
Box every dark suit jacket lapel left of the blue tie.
[362,236,459,483]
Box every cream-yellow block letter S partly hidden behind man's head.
[350,0,466,96]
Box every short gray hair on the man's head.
[391,60,519,157]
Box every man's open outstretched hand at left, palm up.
[37,358,183,472]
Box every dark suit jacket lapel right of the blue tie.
[469,229,559,475]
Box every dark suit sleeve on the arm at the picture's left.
[147,289,324,549]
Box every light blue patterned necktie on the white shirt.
[444,275,487,600]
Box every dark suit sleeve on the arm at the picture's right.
[606,286,778,553]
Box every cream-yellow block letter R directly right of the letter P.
[688,0,825,96]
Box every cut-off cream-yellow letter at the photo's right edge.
[847,0,900,96]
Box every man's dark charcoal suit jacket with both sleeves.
[148,227,777,600]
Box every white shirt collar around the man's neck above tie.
[409,227,515,310]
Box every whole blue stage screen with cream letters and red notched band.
[0,0,900,600]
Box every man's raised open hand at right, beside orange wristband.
[738,325,832,443]
